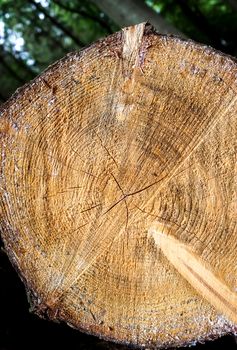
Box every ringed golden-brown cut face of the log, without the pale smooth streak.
[0,24,237,348]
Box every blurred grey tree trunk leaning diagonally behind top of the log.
[92,0,187,38]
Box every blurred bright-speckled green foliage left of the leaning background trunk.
[0,0,118,100]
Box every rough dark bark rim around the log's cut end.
[0,23,237,349]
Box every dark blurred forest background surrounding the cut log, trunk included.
[0,0,237,350]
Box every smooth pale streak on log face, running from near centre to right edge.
[149,224,237,324]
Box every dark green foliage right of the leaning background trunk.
[146,0,237,52]
